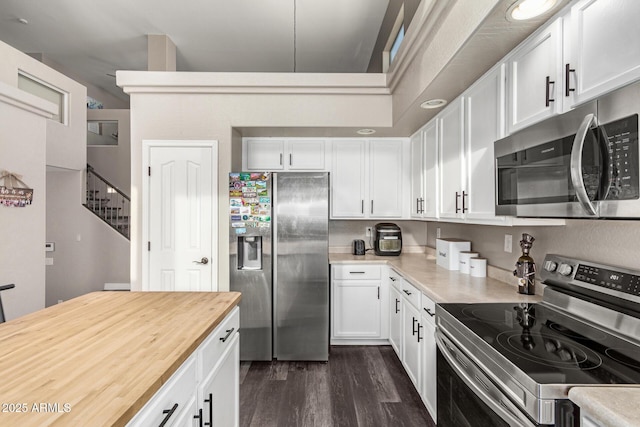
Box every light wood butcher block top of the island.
[0,292,240,427]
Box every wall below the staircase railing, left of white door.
[46,171,130,306]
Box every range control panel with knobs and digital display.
[540,254,640,302]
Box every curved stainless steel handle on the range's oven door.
[436,331,535,427]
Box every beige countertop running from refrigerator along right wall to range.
[329,253,541,303]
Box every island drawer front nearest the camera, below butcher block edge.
[127,354,197,427]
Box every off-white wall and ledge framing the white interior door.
[117,71,391,291]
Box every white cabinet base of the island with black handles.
[127,307,240,427]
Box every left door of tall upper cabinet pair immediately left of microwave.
[439,100,464,218]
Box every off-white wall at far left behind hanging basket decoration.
[0,82,56,320]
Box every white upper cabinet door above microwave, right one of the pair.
[565,0,640,105]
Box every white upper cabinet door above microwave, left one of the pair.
[507,18,563,133]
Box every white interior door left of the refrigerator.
[143,141,218,291]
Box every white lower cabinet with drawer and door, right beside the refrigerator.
[331,264,389,344]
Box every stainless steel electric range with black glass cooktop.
[436,255,640,427]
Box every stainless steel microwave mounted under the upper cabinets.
[494,83,640,218]
